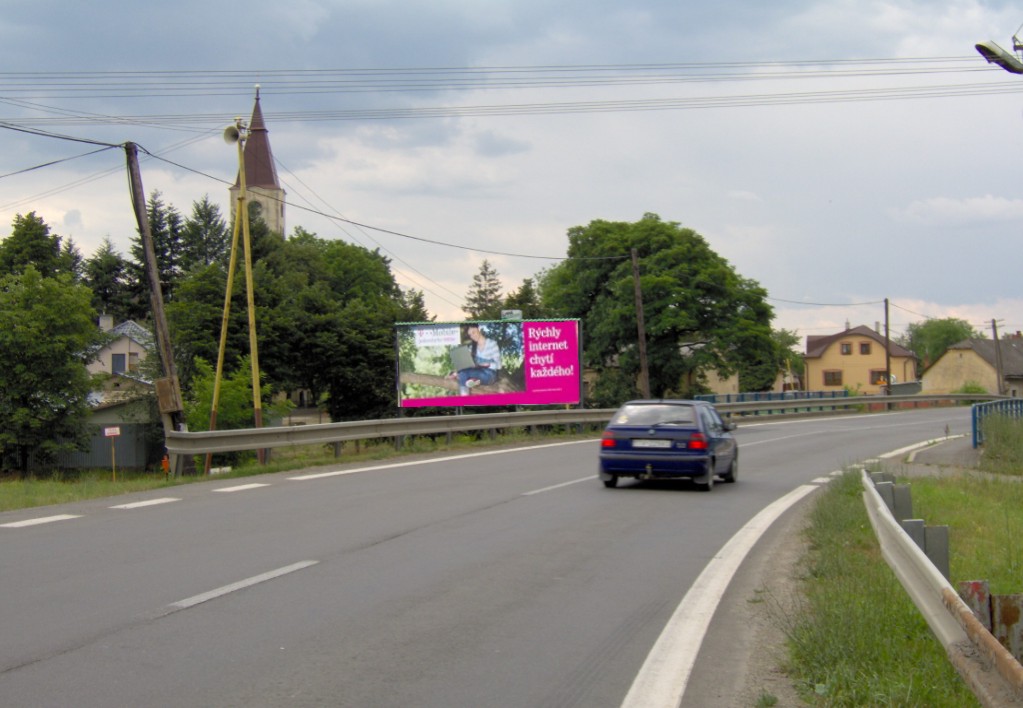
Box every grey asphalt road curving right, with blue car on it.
[0,408,969,708]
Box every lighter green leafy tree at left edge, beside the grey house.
[0,264,102,474]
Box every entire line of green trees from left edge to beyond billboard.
[0,200,795,470]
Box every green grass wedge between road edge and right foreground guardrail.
[782,472,979,708]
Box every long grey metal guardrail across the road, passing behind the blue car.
[166,394,1000,455]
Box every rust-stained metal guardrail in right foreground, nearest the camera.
[861,470,1023,708]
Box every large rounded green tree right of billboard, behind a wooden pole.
[541,214,780,405]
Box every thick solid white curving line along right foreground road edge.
[622,485,817,708]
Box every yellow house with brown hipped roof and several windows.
[803,325,917,394]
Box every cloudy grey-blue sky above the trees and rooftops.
[0,0,1023,351]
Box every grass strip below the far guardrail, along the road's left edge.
[0,429,596,512]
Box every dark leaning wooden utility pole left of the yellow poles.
[125,142,184,477]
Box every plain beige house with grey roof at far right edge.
[923,337,1023,397]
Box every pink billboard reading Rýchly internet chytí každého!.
[395,319,582,408]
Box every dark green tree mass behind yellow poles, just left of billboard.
[167,221,417,419]
